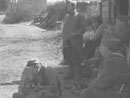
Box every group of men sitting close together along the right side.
[81,15,130,98]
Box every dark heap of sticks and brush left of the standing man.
[31,2,66,30]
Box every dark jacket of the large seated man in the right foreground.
[82,54,129,98]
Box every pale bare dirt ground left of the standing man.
[0,16,79,98]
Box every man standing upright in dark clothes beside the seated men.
[62,2,85,80]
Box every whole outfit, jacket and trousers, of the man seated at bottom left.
[13,60,61,98]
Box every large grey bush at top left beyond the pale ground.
[3,0,46,24]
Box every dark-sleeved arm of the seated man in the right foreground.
[91,57,121,88]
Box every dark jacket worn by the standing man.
[62,13,85,57]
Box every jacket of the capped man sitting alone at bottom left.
[19,66,62,96]
